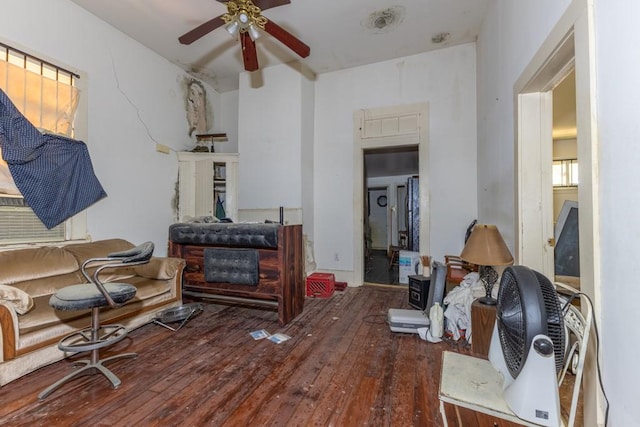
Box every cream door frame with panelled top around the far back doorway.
[353,103,430,286]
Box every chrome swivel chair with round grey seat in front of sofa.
[38,242,154,400]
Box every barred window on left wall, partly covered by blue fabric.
[0,43,86,245]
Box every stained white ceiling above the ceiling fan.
[72,0,489,92]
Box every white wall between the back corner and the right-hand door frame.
[477,0,570,254]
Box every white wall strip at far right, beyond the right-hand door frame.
[595,0,640,426]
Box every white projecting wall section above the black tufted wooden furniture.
[238,64,306,214]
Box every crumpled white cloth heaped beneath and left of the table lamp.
[444,272,497,342]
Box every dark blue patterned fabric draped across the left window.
[0,90,107,228]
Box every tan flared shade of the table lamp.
[460,224,513,266]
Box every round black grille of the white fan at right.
[497,266,564,378]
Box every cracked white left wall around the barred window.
[0,0,220,255]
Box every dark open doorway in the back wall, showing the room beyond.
[363,145,419,285]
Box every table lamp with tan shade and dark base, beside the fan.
[460,224,513,305]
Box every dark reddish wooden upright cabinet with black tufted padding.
[169,223,305,325]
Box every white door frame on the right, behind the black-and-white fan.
[514,0,605,425]
